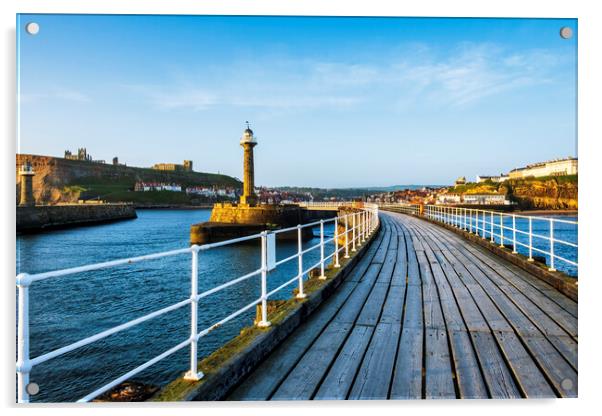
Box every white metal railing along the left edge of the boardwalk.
[16,204,379,403]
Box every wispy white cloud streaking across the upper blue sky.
[124,43,561,111]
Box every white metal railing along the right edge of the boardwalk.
[424,205,578,271]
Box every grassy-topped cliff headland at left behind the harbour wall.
[16,154,241,204]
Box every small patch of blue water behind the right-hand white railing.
[438,214,578,277]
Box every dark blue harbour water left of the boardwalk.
[17,210,333,402]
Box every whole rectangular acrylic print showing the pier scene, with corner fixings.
[16,14,579,402]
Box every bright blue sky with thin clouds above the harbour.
[17,15,577,187]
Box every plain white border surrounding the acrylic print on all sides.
[0,0,602,416]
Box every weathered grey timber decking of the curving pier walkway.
[227,213,577,400]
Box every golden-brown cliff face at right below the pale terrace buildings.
[502,179,578,210]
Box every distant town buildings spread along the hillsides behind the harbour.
[18,147,578,206]
